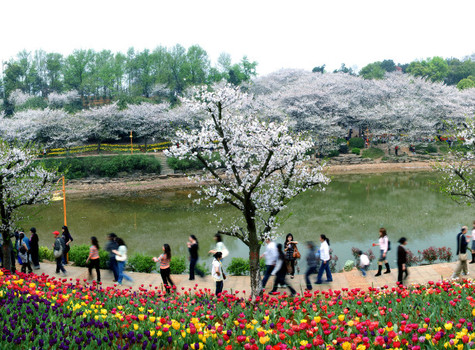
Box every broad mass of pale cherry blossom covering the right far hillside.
[249,70,475,148]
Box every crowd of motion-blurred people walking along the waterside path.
[0,221,475,295]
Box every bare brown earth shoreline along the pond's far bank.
[66,162,432,197]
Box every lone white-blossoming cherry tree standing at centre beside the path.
[169,85,330,297]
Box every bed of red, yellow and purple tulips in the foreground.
[0,271,475,350]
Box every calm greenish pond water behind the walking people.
[17,172,475,268]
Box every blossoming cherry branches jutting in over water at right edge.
[434,116,475,205]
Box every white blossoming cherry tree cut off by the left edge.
[0,140,55,270]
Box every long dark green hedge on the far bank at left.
[37,155,161,179]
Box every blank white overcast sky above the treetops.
[0,0,475,75]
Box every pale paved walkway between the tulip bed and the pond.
[17,262,468,293]
